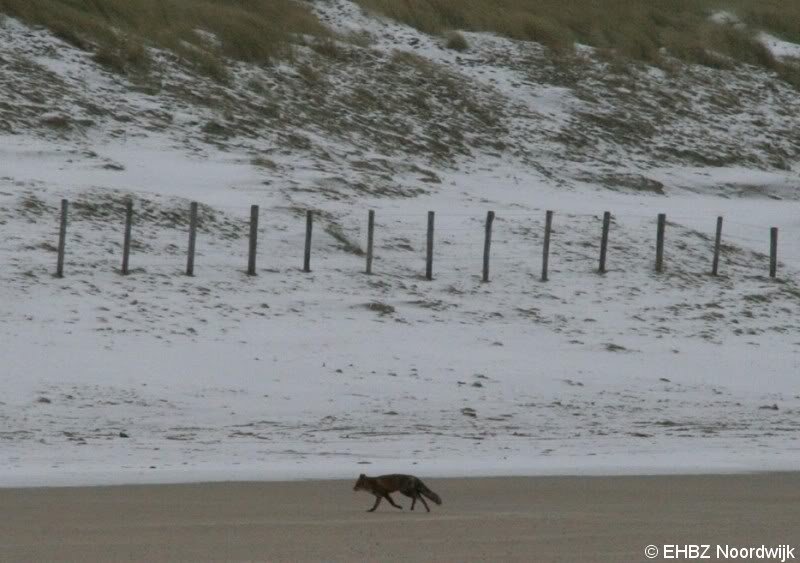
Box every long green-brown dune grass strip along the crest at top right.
[357,0,800,80]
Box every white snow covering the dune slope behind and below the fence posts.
[0,0,800,486]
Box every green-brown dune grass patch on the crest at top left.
[0,0,327,80]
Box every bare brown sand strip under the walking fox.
[0,473,800,562]
